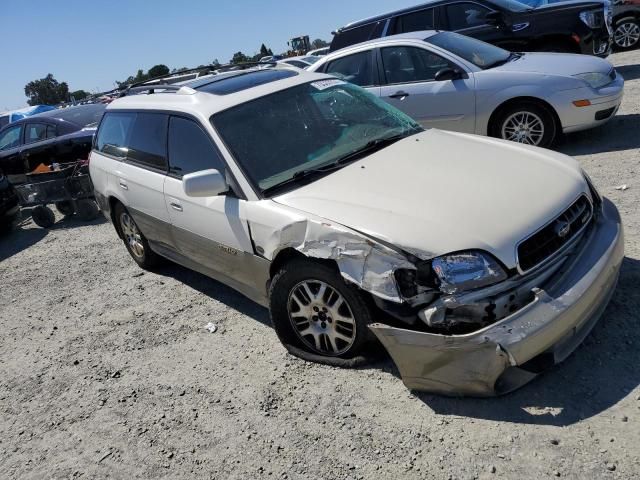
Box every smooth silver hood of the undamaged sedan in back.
[494,53,613,76]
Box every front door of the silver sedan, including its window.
[380,45,475,133]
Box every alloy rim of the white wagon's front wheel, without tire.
[287,280,356,356]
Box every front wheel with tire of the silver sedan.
[490,102,557,148]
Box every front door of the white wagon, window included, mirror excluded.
[164,116,253,284]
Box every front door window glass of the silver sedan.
[382,47,455,84]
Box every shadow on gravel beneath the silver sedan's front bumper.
[556,112,640,155]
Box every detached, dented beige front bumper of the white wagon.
[369,199,624,396]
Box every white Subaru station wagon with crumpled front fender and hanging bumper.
[90,67,624,396]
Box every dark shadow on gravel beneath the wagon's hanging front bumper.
[410,258,640,426]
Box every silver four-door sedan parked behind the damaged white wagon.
[309,31,624,147]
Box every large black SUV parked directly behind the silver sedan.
[331,0,612,57]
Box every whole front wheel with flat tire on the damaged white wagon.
[269,259,372,366]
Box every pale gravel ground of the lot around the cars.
[0,51,640,479]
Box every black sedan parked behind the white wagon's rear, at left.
[0,104,106,183]
